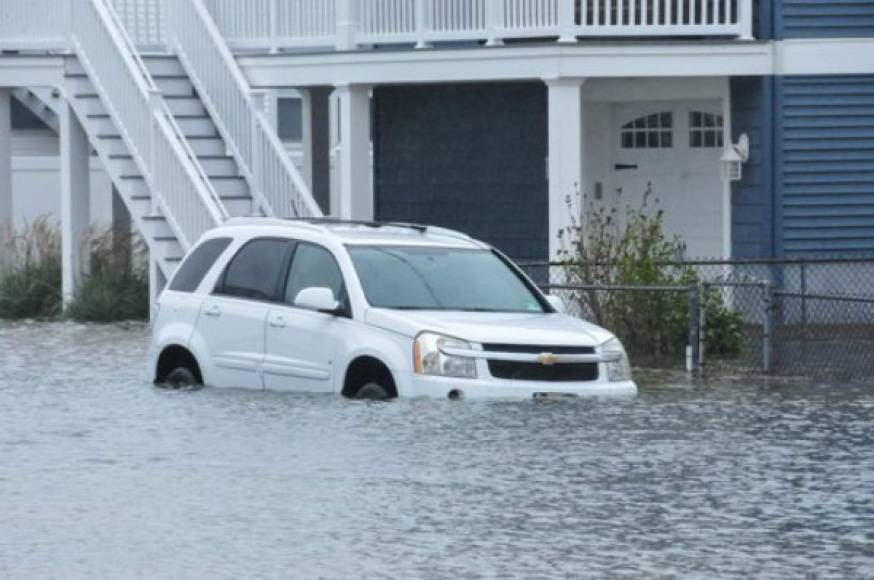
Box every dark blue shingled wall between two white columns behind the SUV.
[374,82,549,260]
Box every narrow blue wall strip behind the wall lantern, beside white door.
[731,77,774,258]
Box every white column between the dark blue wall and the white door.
[546,78,585,260]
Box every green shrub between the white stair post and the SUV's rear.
[67,230,149,322]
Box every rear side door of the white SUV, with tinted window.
[198,238,292,389]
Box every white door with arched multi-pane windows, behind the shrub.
[610,100,729,258]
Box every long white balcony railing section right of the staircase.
[205,0,753,50]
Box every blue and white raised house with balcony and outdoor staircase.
[0,0,874,304]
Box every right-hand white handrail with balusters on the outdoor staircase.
[166,0,322,217]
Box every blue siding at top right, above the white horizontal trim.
[774,0,874,38]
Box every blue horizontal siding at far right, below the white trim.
[775,75,874,255]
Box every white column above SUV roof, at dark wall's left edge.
[331,85,374,221]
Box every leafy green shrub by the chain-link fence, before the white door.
[559,187,743,366]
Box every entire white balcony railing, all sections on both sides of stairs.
[0,0,753,51]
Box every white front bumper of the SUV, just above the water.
[399,373,637,399]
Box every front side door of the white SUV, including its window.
[264,242,352,392]
